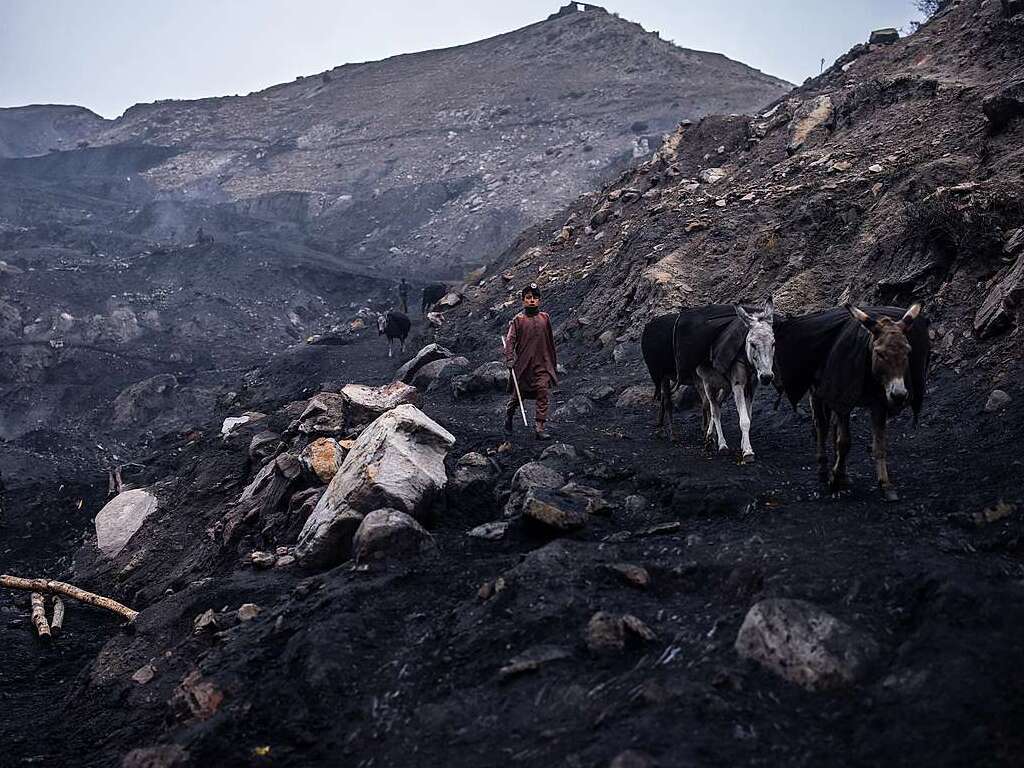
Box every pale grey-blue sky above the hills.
[0,0,918,118]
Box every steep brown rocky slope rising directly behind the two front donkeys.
[454,2,1024,380]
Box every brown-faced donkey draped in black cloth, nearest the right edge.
[776,304,931,502]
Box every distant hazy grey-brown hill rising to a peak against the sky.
[0,3,790,276]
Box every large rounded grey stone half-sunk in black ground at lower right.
[735,598,879,690]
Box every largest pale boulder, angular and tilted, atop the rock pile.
[296,404,455,567]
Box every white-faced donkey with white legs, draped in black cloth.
[672,298,775,464]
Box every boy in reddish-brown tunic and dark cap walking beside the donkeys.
[505,283,558,440]
